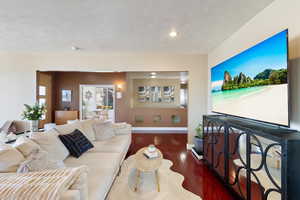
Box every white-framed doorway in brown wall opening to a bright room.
[80,85,115,122]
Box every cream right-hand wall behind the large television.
[208,0,300,129]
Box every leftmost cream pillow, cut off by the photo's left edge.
[0,144,25,173]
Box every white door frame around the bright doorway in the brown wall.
[79,84,116,122]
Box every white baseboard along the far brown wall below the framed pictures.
[132,127,188,134]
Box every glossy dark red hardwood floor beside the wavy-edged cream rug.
[128,134,235,200]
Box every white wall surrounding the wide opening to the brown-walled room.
[0,52,208,142]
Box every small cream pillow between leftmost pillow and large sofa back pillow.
[13,136,41,157]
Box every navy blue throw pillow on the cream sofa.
[58,129,94,158]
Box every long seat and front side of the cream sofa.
[64,134,131,200]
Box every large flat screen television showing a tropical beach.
[211,30,289,126]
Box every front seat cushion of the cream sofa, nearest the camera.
[64,152,122,200]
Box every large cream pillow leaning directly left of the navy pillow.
[31,129,70,160]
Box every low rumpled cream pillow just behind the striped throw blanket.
[17,149,65,173]
